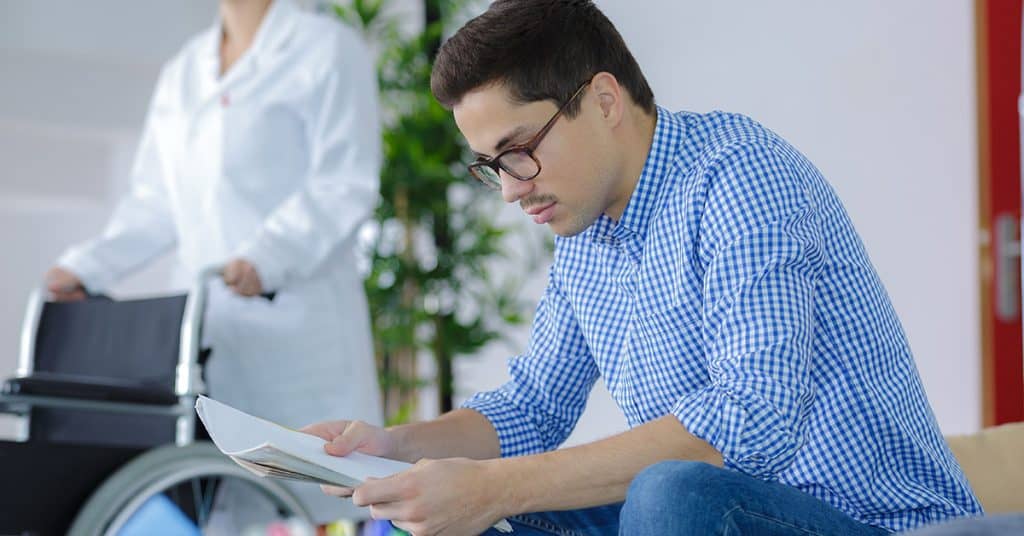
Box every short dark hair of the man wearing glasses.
[430,0,655,117]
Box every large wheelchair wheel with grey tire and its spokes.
[69,442,312,536]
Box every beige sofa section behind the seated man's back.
[947,422,1024,514]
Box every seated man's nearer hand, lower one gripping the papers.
[352,458,507,536]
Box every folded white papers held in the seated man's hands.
[196,397,512,532]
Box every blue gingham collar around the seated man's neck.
[590,107,686,250]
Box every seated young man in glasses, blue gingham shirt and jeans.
[307,0,981,536]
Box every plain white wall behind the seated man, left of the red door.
[454,0,981,443]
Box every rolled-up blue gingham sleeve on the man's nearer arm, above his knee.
[673,141,827,480]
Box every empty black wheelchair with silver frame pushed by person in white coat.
[0,269,312,536]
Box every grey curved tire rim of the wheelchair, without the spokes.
[68,442,312,536]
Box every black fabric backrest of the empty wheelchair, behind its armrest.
[29,295,187,447]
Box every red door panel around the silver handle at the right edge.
[975,0,1024,425]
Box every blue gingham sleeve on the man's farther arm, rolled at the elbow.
[463,268,599,457]
